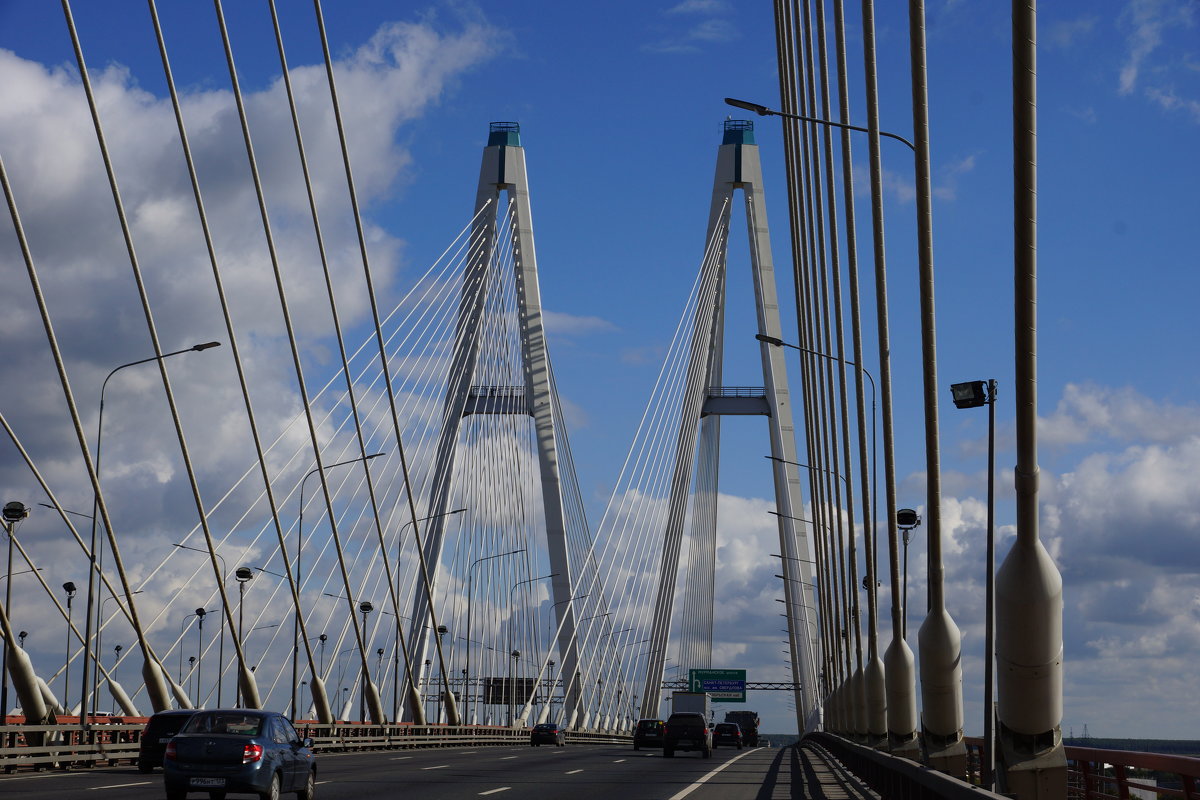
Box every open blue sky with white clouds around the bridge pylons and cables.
[0,0,1200,738]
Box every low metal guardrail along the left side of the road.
[0,722,632,771]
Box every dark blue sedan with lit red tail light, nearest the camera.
[162,709,317,800]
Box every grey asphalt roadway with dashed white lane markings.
[0,744,845,800]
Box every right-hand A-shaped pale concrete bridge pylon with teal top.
[641,120,821,730]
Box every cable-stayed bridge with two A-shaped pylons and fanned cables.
[0,2,1190,796]
